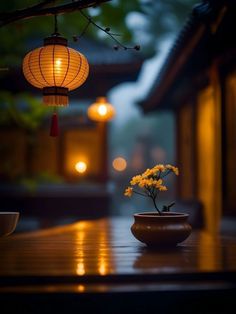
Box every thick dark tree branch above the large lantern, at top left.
[0,0,111,27]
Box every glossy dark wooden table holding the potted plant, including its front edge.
[0,218,236,314]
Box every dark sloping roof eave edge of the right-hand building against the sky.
[139,1,229,112]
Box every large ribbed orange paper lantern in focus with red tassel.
[23,33,89,136]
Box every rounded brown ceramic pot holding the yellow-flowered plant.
[131,212,192,247]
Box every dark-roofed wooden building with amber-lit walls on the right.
[140,0,236,231]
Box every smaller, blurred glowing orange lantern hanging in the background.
[88,97,115,122]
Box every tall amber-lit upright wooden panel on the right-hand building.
[196,65,222,232]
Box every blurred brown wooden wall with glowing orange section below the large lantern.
[0,123,107,182]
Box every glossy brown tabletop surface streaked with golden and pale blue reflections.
[0,218,236,278]
